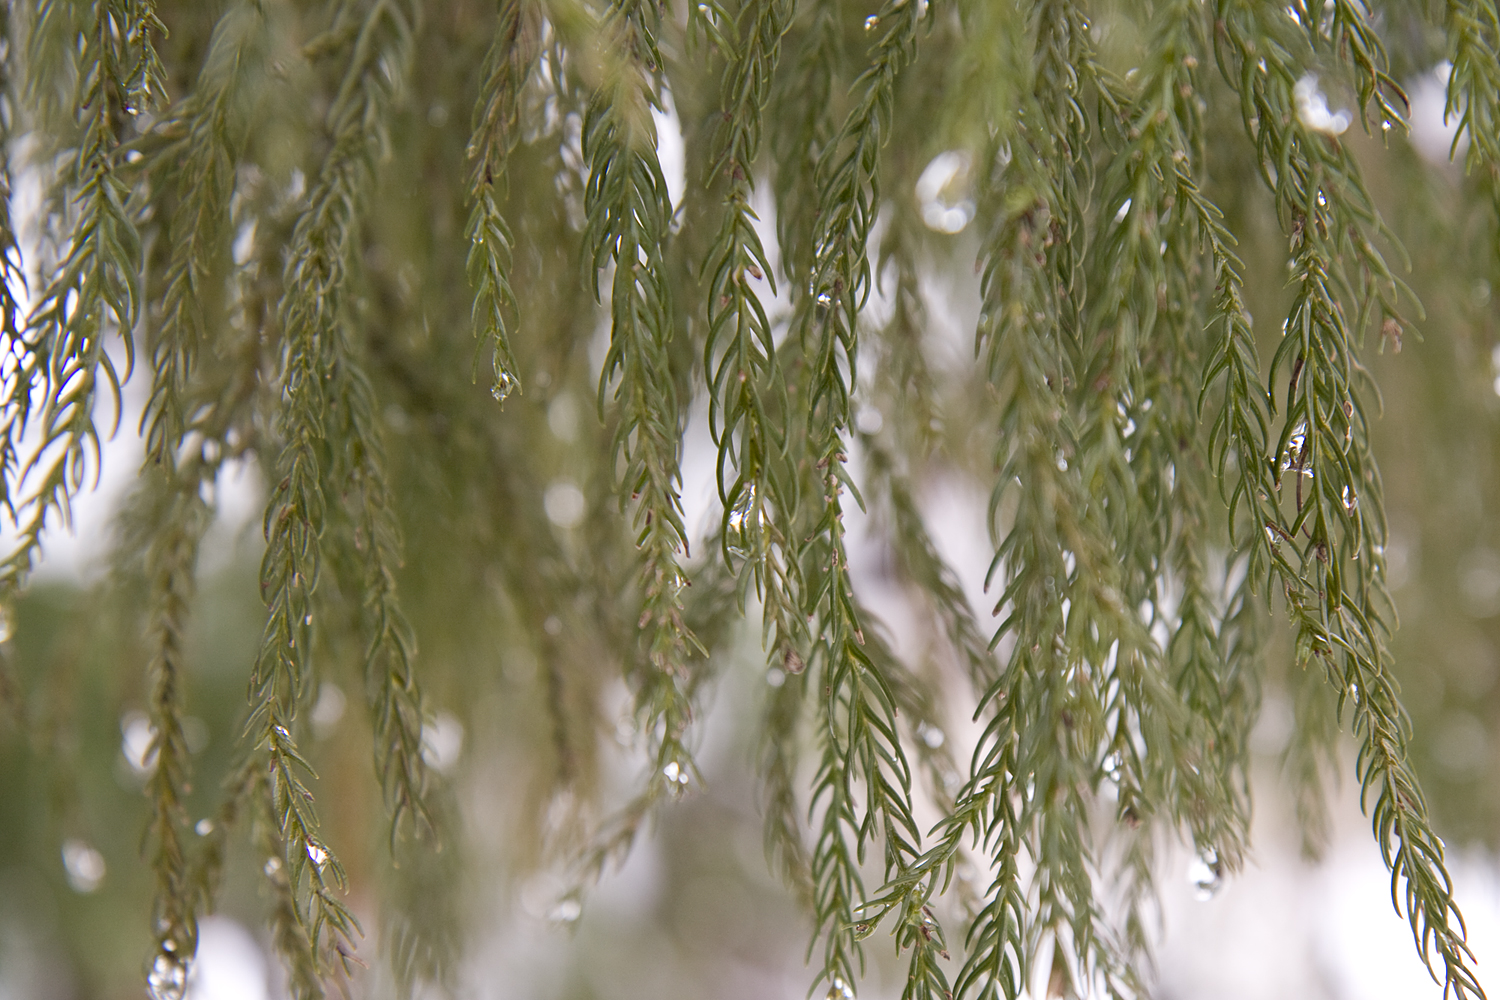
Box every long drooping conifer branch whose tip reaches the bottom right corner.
[1218,0,1482,997]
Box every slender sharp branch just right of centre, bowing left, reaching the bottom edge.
[788,0,947,997]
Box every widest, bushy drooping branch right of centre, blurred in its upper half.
[924,3,1170,997]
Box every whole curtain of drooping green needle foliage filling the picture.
[0,0,1500,1000]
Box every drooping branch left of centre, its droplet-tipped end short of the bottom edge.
[584,0,698,798]
